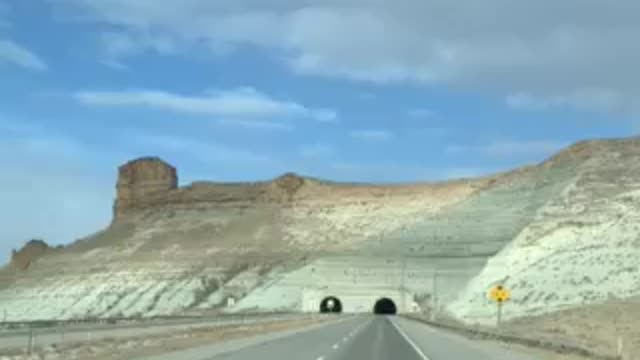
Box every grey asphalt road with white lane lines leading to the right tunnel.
[140,315,542,360]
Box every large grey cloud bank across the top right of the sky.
[49,0,640,111]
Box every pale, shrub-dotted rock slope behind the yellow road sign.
[447,139,640,323]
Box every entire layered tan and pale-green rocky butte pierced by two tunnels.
[0,138,640,323]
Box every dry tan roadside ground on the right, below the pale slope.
[408,298,640,360]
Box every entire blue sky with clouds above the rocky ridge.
[0,0,640,262]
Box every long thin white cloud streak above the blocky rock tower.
[74,88,338,122]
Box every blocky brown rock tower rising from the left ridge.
[114,157,178,219]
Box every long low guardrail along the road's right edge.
[401,315,627,360]
